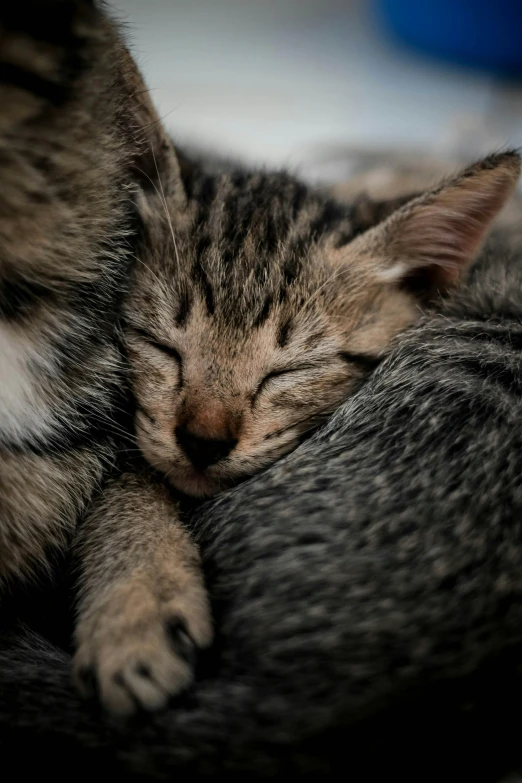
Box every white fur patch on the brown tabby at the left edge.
[0,323,54,443]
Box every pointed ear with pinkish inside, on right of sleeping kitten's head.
[350,152,520,297]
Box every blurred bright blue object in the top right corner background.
[376,0,522,76]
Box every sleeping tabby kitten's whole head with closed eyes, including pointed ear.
[125,147,520,497]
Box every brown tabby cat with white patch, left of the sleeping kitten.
[0,0,181,585]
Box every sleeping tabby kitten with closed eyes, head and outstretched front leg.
[72,138,520,714]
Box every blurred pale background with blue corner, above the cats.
[113,0,522,181]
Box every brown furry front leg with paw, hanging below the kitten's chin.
[75,474,212,715]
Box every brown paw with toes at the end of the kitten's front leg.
[74,579,212,716]
